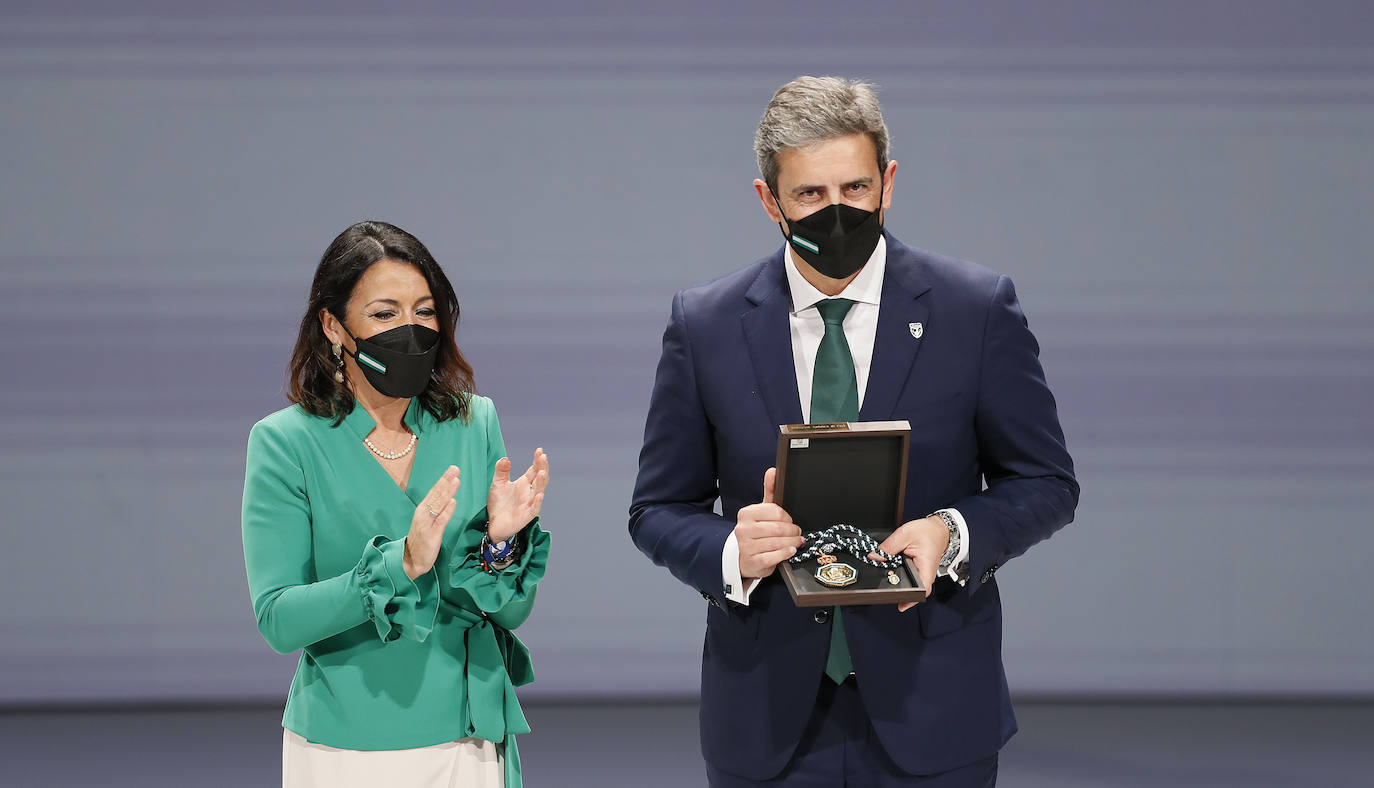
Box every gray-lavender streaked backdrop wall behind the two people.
[0,0,1374,703]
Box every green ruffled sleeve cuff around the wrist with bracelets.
[448,508,550,612]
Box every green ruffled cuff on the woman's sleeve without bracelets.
[353,535,438,642]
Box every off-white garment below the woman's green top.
[282,728,506,788]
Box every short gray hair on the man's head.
[754,77,888,191]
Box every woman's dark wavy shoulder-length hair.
[286,221,474,426]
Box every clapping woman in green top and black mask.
[243,222,550,788]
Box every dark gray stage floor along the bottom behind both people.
[0,702,1374,788]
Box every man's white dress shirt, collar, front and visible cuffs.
[720,236,969,604]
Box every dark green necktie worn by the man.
[811,298,859,684]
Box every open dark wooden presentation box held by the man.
[774,421,926,607]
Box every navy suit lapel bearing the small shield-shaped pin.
[857,235,930,421]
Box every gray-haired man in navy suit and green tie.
[629,77,1079,788]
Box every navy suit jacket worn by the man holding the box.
[629,235,1079,780]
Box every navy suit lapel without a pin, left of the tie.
[739,253,801,424]
